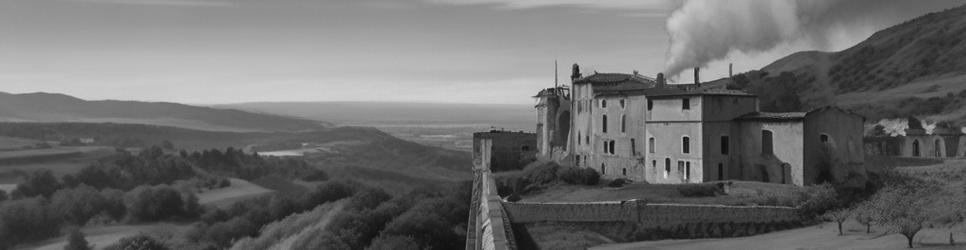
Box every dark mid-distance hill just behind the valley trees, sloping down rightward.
[0,122,472,181]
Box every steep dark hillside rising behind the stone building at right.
[730,3,966,125]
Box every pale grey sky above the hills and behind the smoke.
[0,0,954,104]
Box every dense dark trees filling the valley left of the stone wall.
[0,145,470,249]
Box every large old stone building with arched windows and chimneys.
[536,65,864,185]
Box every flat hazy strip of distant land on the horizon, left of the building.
[214,102,536,129]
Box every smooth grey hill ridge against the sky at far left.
[0,92,326,131]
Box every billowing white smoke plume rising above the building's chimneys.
[665,0,962,77]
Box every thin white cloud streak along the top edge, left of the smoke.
[426,0,669,10]
